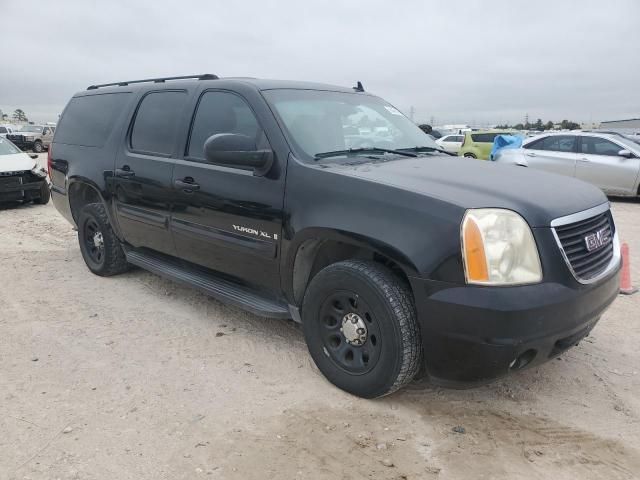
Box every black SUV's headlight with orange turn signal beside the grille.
[461,208,542,285]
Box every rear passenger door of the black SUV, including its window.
[112,90,188,255]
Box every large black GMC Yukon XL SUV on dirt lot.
[49,74,620,398]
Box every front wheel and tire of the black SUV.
[302,260,422,398]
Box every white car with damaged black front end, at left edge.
[0,138,49,204]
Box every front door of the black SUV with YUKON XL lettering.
[171,90,284,290]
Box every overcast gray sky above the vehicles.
[0,0,640,124]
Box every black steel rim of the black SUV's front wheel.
[318,290,382,375]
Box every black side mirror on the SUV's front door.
[204,133,273,175]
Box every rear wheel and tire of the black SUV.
[78,203,129,277]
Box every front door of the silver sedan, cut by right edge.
[576,136,640,194]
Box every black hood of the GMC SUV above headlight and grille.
[322,155,607,227]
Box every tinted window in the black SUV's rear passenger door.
[131,91,187,155]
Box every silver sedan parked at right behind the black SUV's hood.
[495,132,640,196]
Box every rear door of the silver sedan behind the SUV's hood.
[523,135,577,177]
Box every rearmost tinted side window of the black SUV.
[55,93,129,147]
